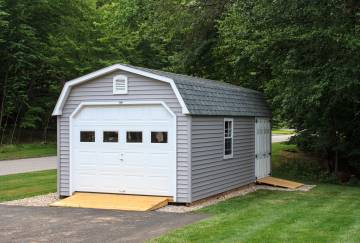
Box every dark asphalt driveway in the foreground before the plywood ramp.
[0,205,208,242]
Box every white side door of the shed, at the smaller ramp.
[255,118,271,179]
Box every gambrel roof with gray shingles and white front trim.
[53,64,271,117]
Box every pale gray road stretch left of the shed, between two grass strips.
[0,156,56,175]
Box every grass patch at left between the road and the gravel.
[0,170,56,202]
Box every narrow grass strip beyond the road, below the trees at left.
[0,143,56,160]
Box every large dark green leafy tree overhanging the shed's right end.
[218,0,360,176]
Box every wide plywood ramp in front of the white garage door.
[50,192,171,211]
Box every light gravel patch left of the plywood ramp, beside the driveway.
[0,193,59,207]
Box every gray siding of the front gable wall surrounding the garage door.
[58,71,190,202]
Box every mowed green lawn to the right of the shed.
[154,144,360,242]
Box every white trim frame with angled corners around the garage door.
[69,101,177,202]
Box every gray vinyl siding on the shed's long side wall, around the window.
[191,116,255,201]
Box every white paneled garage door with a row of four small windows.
[71,105,176,196]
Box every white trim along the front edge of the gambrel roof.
[52,64,190,116]
